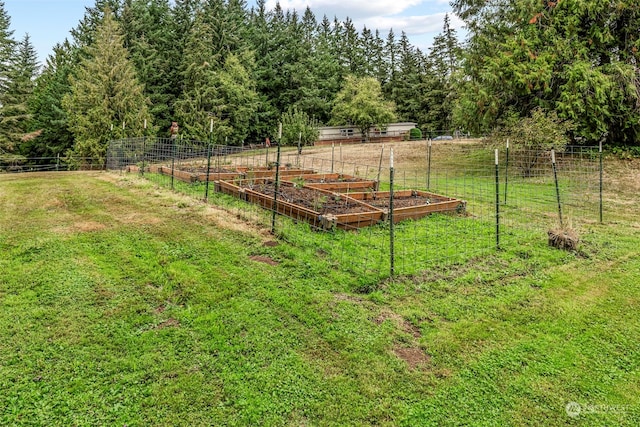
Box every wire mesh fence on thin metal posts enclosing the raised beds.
[107,138,603,283]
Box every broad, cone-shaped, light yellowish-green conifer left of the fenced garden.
[63,9,151,163]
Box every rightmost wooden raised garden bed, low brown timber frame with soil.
[349,190,466,222]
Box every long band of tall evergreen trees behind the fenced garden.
[0,0,640,166]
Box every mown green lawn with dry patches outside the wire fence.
[0,155,640,426]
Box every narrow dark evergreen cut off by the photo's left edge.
[0,34,39,152]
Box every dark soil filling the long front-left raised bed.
[251,184,371,215]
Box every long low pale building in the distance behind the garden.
[316,122,416,145]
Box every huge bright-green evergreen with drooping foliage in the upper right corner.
[452,0,640,144]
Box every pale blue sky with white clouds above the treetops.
[0,0,464,63]
